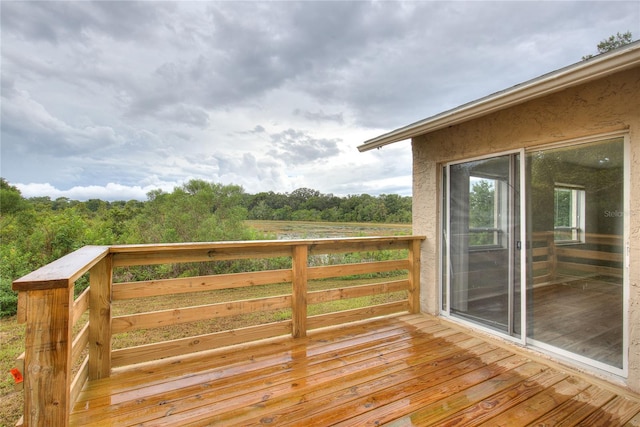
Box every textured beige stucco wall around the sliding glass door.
[412,68,640,392]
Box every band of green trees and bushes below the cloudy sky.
[0,178,411,316]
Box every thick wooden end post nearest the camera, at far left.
[13,279,74,426]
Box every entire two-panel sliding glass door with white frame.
[442,137,628,374]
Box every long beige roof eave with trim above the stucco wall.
[358,41,640,152]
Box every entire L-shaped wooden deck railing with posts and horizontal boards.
[13,236,424,426]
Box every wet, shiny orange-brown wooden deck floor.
[70,315,640,426]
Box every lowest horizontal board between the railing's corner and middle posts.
[111,320,291,368]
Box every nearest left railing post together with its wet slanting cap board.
[12,246,109,427]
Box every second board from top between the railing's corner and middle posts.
[113,269,292,301]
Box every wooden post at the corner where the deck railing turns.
[89,255,112,380]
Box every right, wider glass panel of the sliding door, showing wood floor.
[526,138,625,368]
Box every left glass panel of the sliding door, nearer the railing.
[443,154,521,336]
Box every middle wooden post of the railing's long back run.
[291,244,309,338]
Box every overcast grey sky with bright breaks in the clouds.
[0,0,640,200]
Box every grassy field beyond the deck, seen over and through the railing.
[0,221,411,427]
